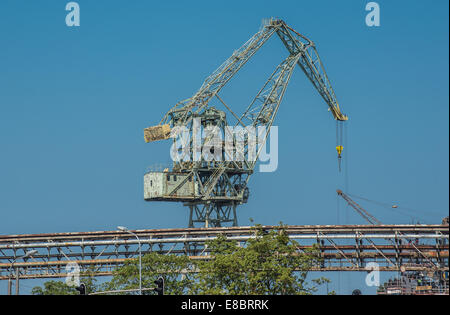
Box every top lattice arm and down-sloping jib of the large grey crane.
[148,19,348,142]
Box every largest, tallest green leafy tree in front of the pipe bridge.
[192,225,328,295]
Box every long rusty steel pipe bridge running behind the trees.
[0,225,449,280]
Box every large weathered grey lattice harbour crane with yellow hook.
[144,19,348,227]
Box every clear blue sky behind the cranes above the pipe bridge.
[0,0,449,296]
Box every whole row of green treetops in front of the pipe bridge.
[33,225,329,295]
